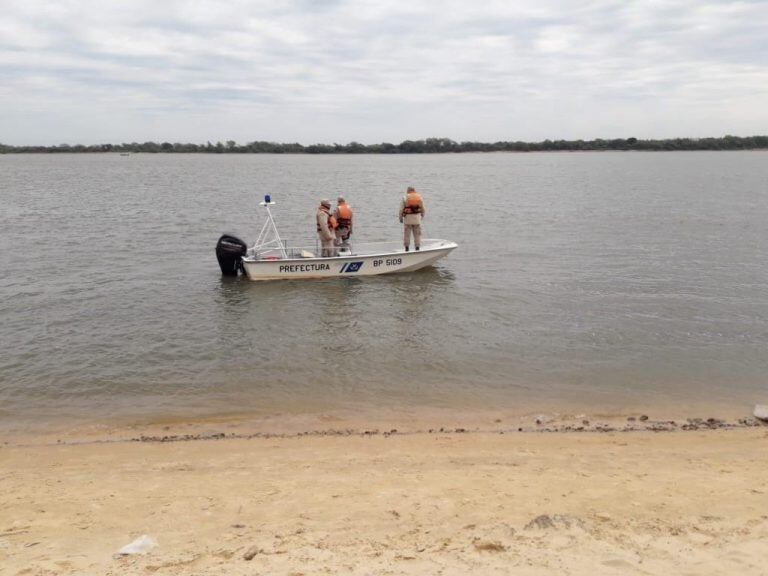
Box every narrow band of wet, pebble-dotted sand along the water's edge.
[0,403,760,445]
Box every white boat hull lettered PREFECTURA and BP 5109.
[243,240,456,280]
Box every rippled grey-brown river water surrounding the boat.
[0,152,768,428]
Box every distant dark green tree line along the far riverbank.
[0,136,768,154]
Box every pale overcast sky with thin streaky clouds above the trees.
[0,0,768,144]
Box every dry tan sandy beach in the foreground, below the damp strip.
[0,426,768,576]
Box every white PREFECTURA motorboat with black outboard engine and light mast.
[216,196,457,280]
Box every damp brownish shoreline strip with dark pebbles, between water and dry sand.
[0,402,768,446]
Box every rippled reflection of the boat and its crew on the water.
[210,267,455,366]
